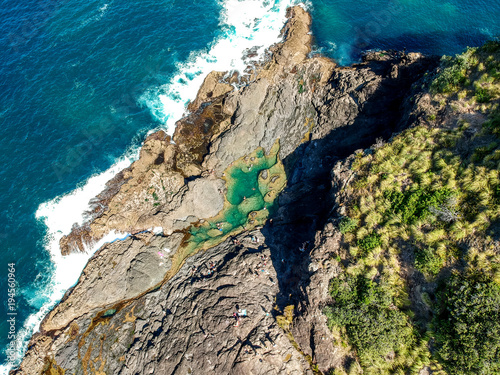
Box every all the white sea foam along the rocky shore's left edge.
[0,0,300,374]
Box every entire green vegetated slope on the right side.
[324,42,500,374]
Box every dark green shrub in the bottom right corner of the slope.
[434,273,500,375]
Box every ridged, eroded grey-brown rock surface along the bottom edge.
[18,232,312,375]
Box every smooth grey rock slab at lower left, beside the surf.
[39,233,183,331]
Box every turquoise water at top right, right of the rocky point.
[312,0,500,65]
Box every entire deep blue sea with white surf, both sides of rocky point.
[0,0,500,374]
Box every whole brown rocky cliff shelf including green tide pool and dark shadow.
[13,7,446,374]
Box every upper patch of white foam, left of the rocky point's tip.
[140,0,294,134]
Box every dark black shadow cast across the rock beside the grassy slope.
[262,54,437,311]
